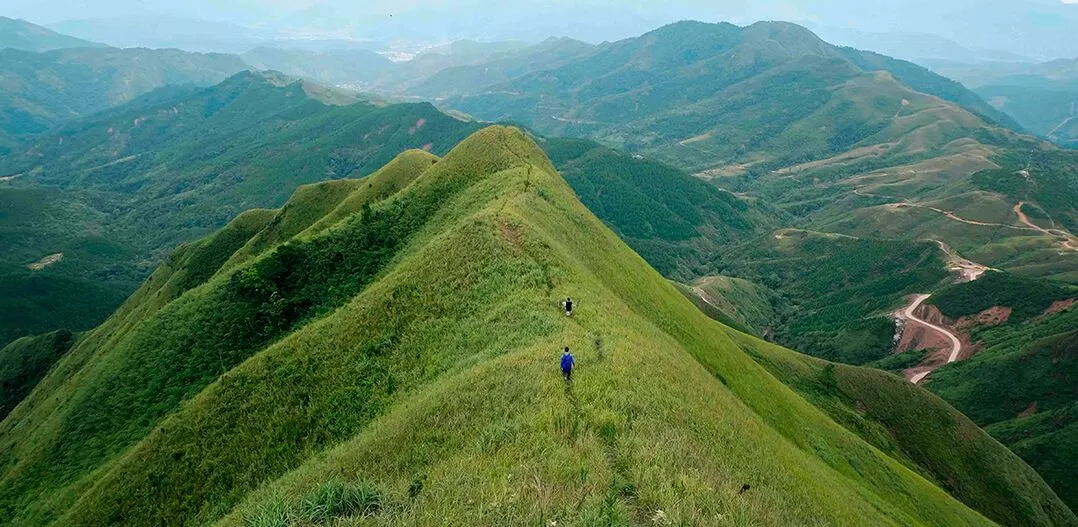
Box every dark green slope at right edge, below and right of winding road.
[905,273,1078,508]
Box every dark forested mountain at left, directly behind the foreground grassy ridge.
[0,72,476,349]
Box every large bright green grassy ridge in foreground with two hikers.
[0,127,1078,526]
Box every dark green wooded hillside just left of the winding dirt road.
[721,230,948,364]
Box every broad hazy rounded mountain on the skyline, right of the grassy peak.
[446,22,1013,170]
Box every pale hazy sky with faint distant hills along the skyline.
[6,0,1078,59]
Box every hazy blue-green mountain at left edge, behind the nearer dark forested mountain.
[0,47,248,154]
